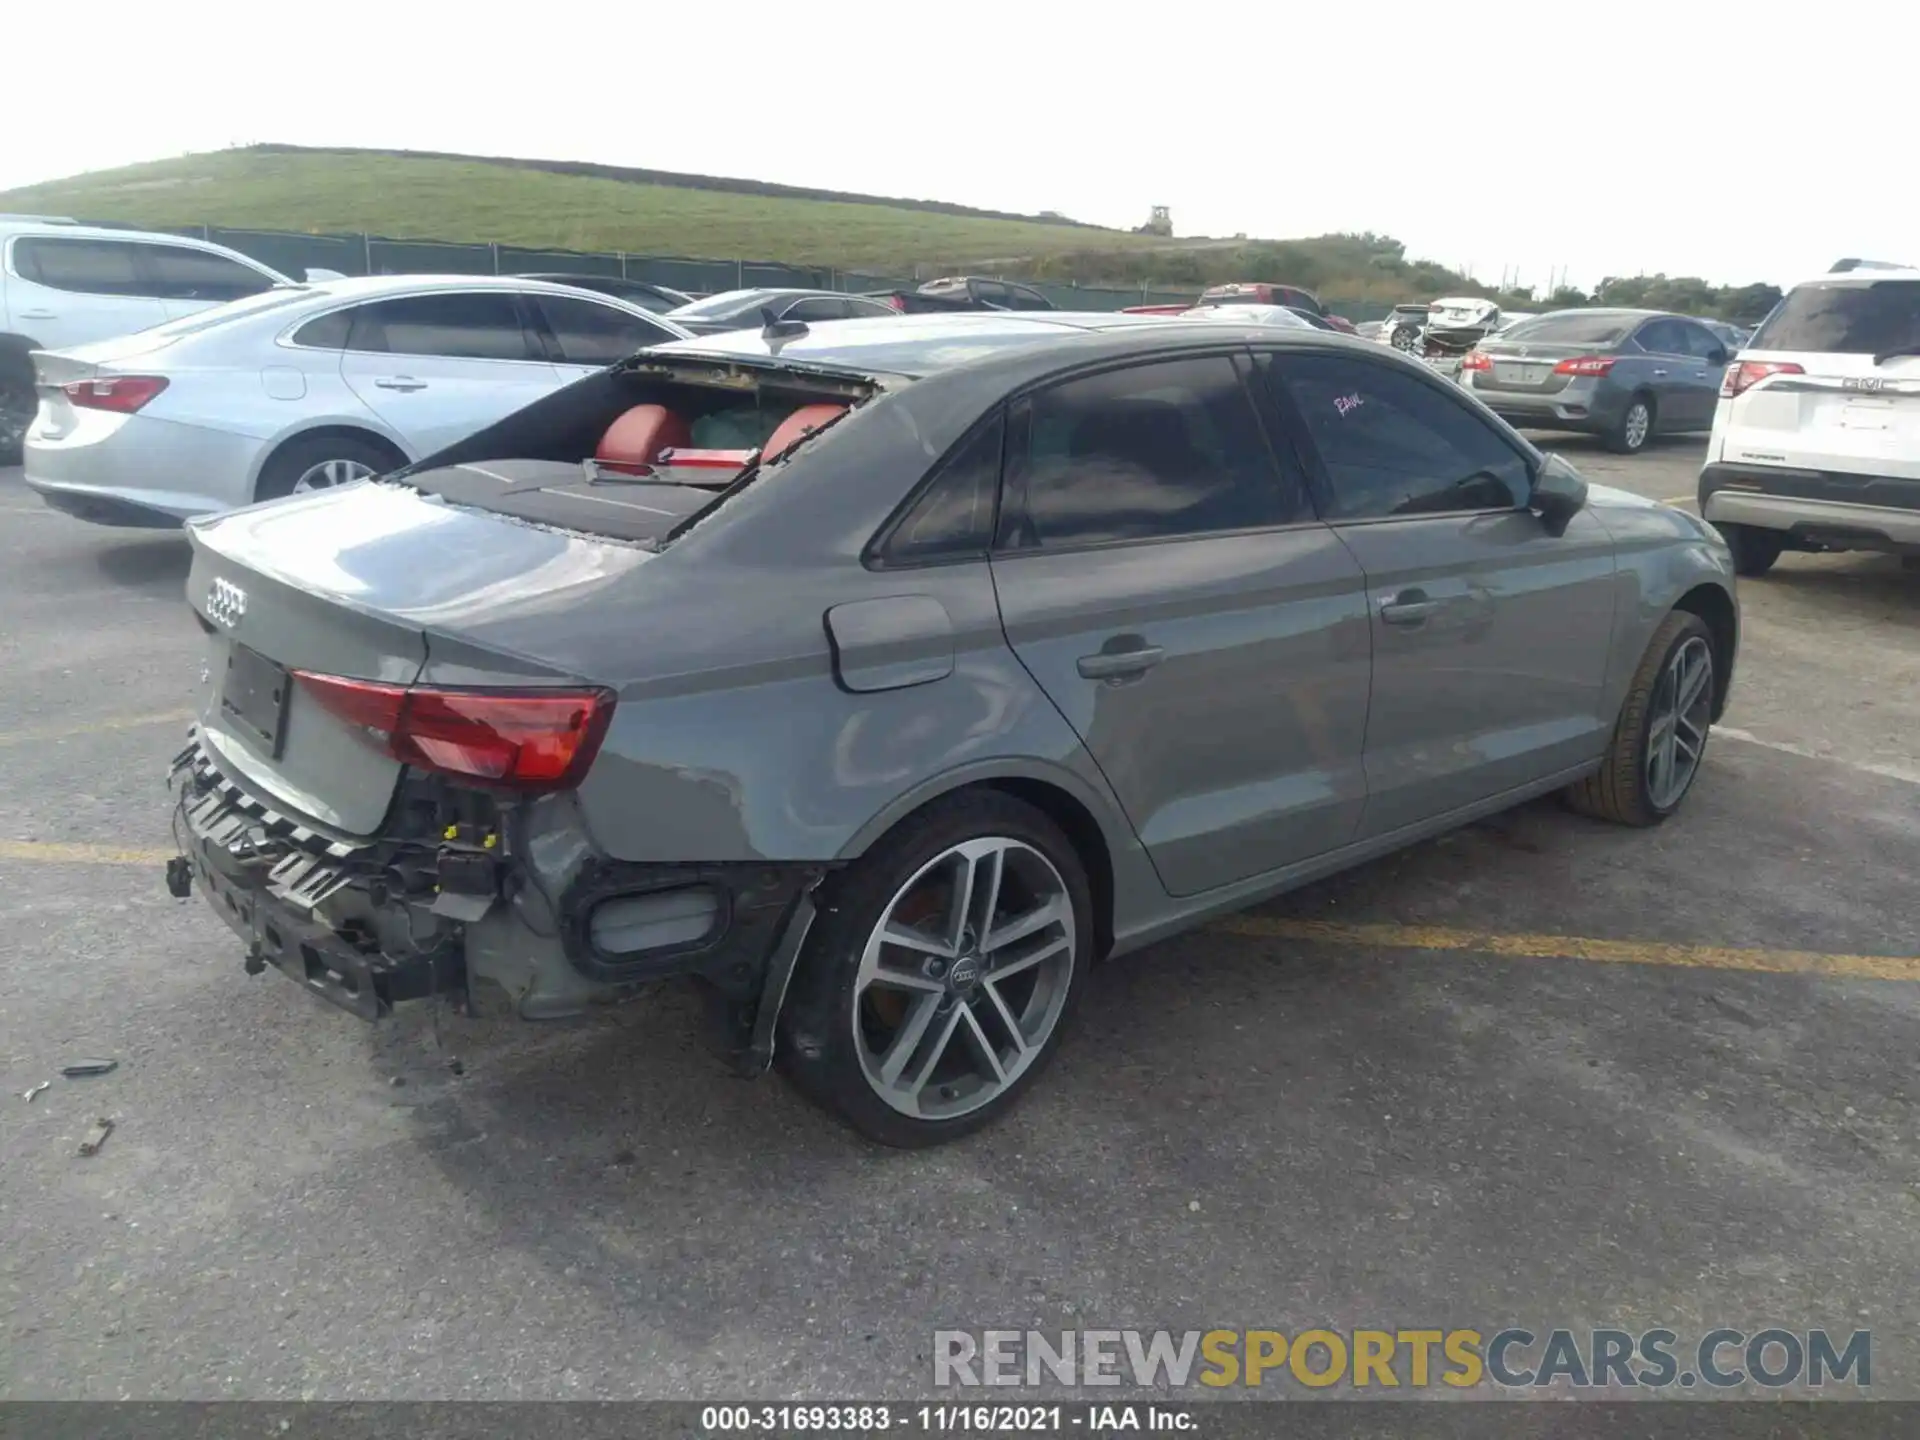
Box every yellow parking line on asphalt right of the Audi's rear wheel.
[1212,916,1920,979]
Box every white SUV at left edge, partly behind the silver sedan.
[0,215,292,465]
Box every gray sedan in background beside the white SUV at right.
[1459,309,1732,455]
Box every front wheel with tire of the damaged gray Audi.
[1567,611,1716,826]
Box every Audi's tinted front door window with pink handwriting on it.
[1273,355,1532,520]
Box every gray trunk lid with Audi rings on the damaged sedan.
[186,482,649,837]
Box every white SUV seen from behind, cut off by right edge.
[1699,261,1920,576]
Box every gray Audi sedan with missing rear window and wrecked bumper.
[167,313,1740,1146]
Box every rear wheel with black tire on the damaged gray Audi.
[780,791,1092,1148]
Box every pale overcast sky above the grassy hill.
[0,0,1920,286]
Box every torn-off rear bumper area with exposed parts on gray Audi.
[167,739,826,1075]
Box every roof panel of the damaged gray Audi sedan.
[647,311,1382,384]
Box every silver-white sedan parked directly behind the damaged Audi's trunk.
[25,275,687,526]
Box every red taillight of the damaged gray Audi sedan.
[294,670,612,789]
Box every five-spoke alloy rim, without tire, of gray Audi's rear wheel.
[851,835,1077,1119]
